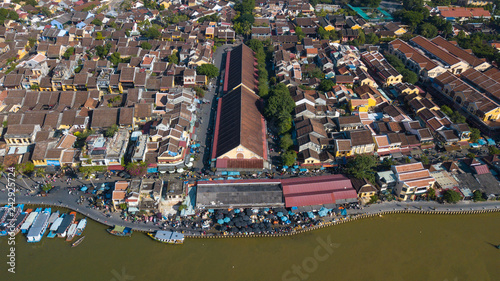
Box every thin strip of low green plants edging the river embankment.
[8,203,500,239]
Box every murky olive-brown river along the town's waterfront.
[0,213,500,281]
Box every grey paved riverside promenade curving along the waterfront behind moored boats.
[0,188,500,238]
